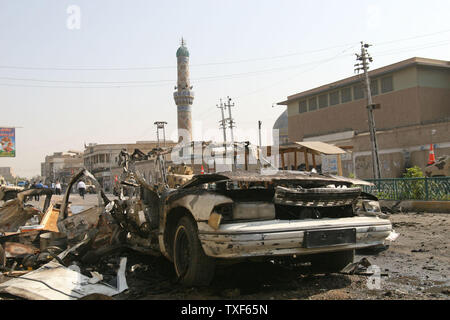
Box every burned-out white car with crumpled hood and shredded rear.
[106,144,392,285]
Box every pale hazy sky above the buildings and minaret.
[0,0,450,177]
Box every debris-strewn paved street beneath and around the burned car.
[0,190,450,300]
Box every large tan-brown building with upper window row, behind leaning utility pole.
[274,58,450,178]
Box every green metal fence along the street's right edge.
[363,177,450,201]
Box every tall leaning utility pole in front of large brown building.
[355,41,381,179]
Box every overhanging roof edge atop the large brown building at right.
[277,57,450,105]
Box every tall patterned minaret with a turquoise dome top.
[173,38,194,143]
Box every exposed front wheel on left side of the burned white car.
[173,216,215,286]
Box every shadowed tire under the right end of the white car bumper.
[310,250,355,273]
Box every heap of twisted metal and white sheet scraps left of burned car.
[0,169,134,300]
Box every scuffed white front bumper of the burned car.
[199,217,392,258]
